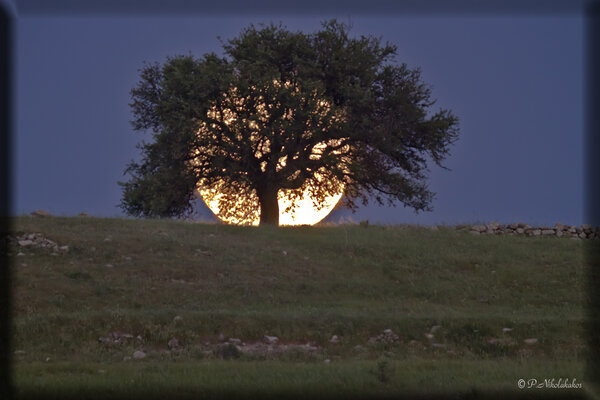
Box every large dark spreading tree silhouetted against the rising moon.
[120,20,458,225]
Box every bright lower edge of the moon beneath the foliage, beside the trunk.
[198,178,343,226]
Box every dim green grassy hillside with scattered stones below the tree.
[4,217,589,398]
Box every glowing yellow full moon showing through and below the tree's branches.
[192,80,347,225]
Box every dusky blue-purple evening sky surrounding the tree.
[4,1,586,225]
